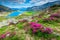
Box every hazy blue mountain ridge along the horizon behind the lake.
[0,1,60,11]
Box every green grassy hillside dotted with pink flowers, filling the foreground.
[0,5,60,40]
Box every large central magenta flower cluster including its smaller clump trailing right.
[30,22,52,34]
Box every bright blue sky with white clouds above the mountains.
[0,0,58,8]
